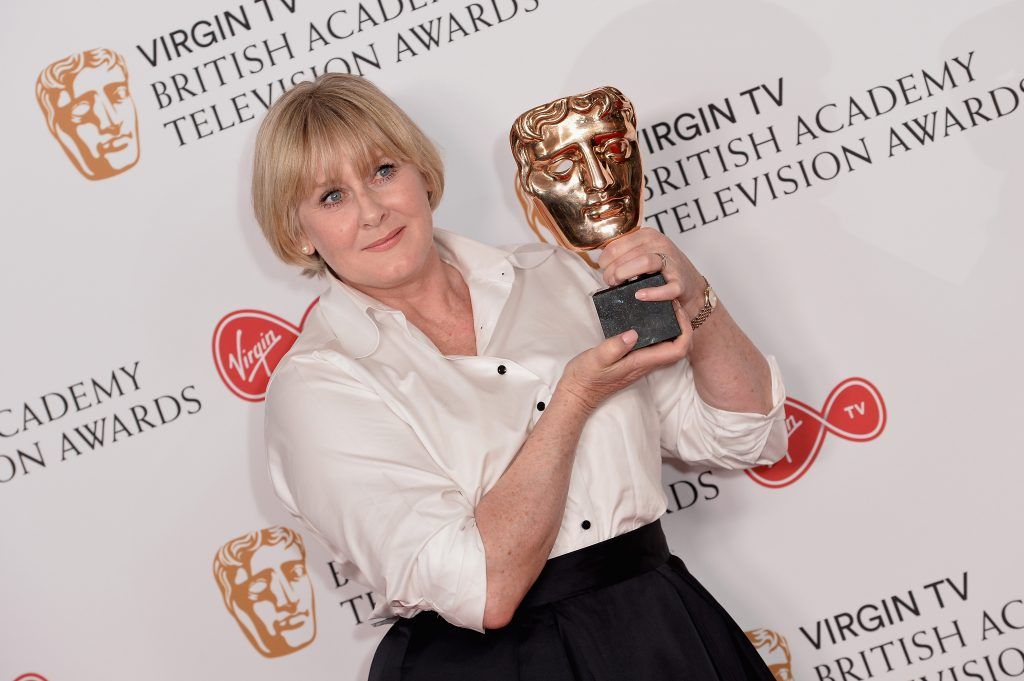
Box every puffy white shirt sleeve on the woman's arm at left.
[265,357,486,633]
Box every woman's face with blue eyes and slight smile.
[298,156,433,290]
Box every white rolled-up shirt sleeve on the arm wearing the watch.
[647,355,787,468]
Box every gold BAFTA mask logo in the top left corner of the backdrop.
[36,49,139,179]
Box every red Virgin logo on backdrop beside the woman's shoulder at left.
[213,300,316,402]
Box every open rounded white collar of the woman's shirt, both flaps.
[318,227,554,359]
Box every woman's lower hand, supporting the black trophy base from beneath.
[556,303,693,416]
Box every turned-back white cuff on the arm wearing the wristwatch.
[693,354,787,468]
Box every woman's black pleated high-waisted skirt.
[370,520,773,681]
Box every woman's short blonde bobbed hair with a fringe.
[252,74,444,276]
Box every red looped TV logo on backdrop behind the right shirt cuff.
[743,378,886,487]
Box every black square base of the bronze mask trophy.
[594,272,683,350]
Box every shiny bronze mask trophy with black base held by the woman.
[509,87,682,349]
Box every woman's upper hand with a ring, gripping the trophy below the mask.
[598,227,705,315]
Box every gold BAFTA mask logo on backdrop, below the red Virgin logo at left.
[213,526,316,657]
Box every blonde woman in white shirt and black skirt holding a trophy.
[253,74,785,680]
